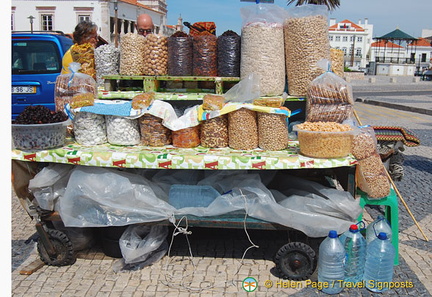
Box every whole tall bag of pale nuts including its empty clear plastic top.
[240,4,286,96]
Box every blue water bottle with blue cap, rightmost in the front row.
[363,232,395,292]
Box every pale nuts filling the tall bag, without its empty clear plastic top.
[240,24,285,96]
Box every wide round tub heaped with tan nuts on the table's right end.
[294,122,353,158]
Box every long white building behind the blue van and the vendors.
[11,0,173,42]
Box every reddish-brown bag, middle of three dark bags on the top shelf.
[192,35,217,76]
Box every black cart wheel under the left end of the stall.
[37,229,76,266]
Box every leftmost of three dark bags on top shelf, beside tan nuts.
[168,31,192,76]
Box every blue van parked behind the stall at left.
[12,31,73,120]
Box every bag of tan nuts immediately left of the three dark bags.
[143,34,168,75]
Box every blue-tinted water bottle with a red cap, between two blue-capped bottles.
[340,225,366,285]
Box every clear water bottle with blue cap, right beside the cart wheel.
[318,230,345,294]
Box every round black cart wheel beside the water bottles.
[275,242,317,280]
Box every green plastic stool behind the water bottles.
[357,188,399,265]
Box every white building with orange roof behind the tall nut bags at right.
[329,18,373,70]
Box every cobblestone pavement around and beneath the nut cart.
[11,77,432,297]
